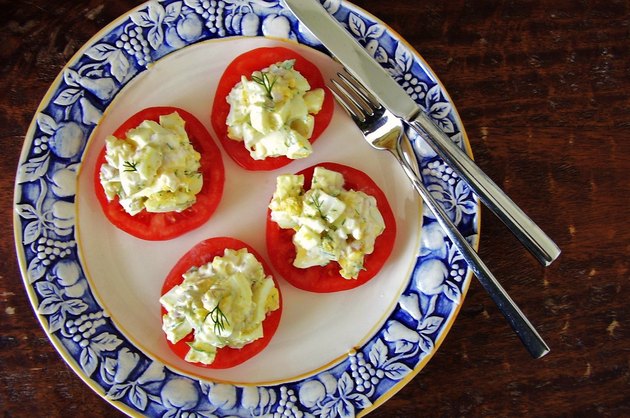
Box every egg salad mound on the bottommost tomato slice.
[160,248,280,364]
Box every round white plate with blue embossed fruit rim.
[14,0,479,417]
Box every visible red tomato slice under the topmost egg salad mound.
[211,47,334,171]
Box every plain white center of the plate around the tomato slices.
[77,38,422,384]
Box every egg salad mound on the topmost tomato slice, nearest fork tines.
[226,60,324,160]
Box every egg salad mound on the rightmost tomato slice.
[269,167,385,279]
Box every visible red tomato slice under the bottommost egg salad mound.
[161,237,282,369]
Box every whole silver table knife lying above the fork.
[283,0,560,266]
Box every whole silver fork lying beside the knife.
[329,72,549,358]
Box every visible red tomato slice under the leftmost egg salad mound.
[94,106,225,241]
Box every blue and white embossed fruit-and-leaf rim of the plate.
[15,0,478,418]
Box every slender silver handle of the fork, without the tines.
[392,135,549,359]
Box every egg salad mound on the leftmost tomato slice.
[100,112,203,215]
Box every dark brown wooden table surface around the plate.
[0,0,630,417]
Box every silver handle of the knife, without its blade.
[408,112,560,266]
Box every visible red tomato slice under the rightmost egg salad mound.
[266,162,396,293]
